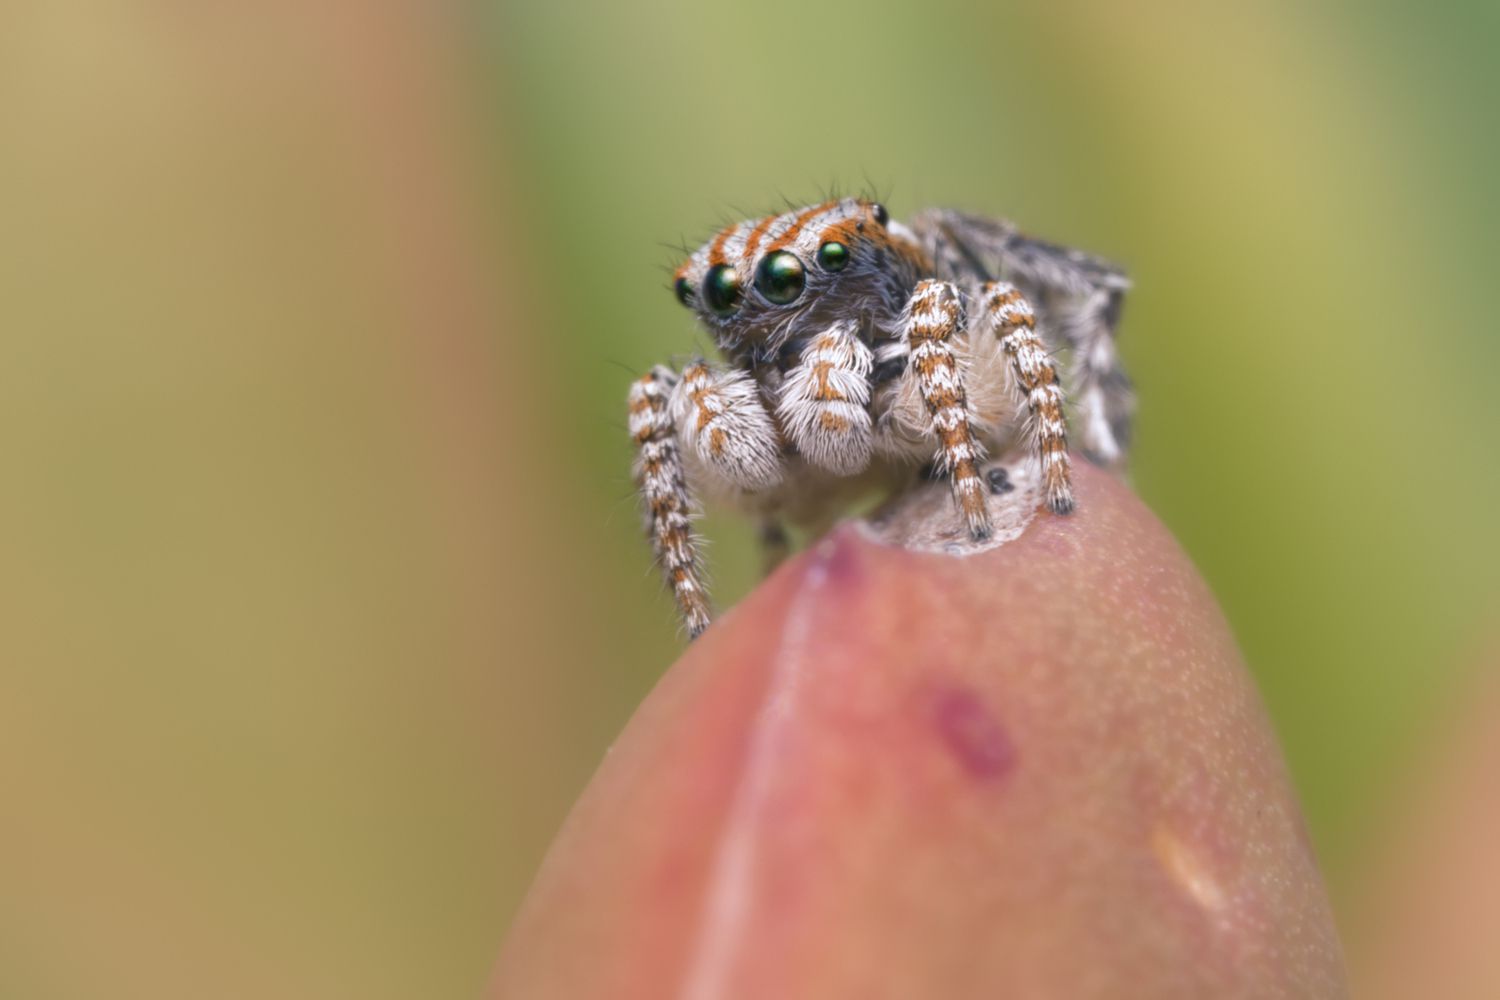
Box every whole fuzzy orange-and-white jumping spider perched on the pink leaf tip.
[630,198,1133,636]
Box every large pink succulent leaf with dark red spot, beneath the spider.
[494,469,1346,1000]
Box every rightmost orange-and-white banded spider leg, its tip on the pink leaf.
[975,282,1073,514]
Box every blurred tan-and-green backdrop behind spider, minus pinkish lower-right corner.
[0,0,1500,997]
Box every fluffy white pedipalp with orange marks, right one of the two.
[776,322,875,475]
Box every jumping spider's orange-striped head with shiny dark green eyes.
[674,198,924,358]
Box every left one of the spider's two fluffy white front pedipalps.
[672,360,782,492]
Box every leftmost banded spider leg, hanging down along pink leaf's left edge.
[630,366,711,639]
